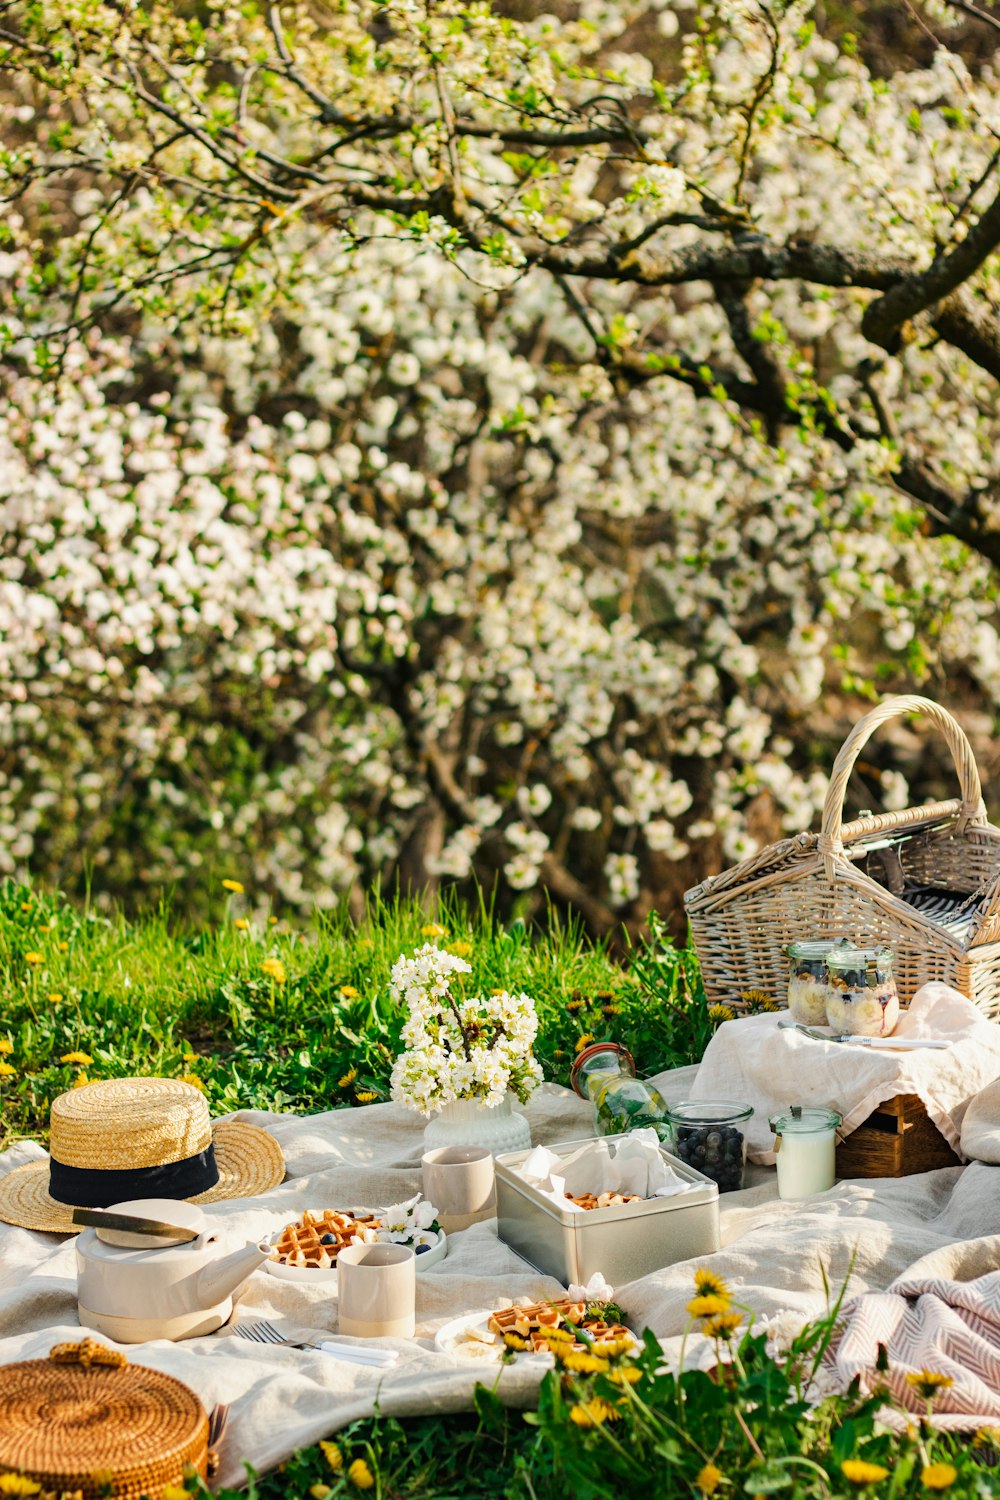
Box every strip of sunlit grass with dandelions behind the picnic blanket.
[0,882,711,1148]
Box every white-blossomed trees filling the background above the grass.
[0,0,1000,929]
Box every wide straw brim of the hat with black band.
[0,1121,285,1235]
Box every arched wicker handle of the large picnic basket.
[819,693,987,876]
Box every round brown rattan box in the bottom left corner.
[0,1338,208,1500]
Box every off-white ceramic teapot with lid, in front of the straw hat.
[76,1199,270,1344]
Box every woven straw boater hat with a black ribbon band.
[0,1079,285,1235]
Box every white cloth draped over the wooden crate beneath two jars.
[691,983,1000,1166]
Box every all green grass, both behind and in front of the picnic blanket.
[0,882,1000,1500]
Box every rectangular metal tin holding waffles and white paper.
[496,1136,720,1287]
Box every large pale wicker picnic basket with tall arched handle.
[684,695,1000,1016]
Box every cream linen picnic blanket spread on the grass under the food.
[0,1068,1000,1485]
